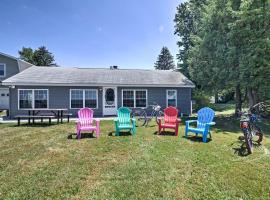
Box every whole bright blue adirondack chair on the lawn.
[185,107,216,142]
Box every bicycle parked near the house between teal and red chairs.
[131,103,164,127]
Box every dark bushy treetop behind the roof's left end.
[19,46,56,66]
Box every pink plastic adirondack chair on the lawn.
[76,108,100,139]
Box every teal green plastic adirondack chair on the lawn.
[114,107,136,136]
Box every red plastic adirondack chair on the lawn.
[158,106,181,136]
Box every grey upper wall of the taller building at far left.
[0,55,19,82]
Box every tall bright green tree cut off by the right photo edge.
[231,0,270,106]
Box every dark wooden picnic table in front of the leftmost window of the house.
[28,108,68,123]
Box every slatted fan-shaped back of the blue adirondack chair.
[197,107,215,129]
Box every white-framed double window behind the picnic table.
[18,89,49,109]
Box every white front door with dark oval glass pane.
[103,87,117,115]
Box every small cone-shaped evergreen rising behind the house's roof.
[154,47,175,70]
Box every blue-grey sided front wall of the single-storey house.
[10,86,191,118]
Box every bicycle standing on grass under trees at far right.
[239,103,263,154]
